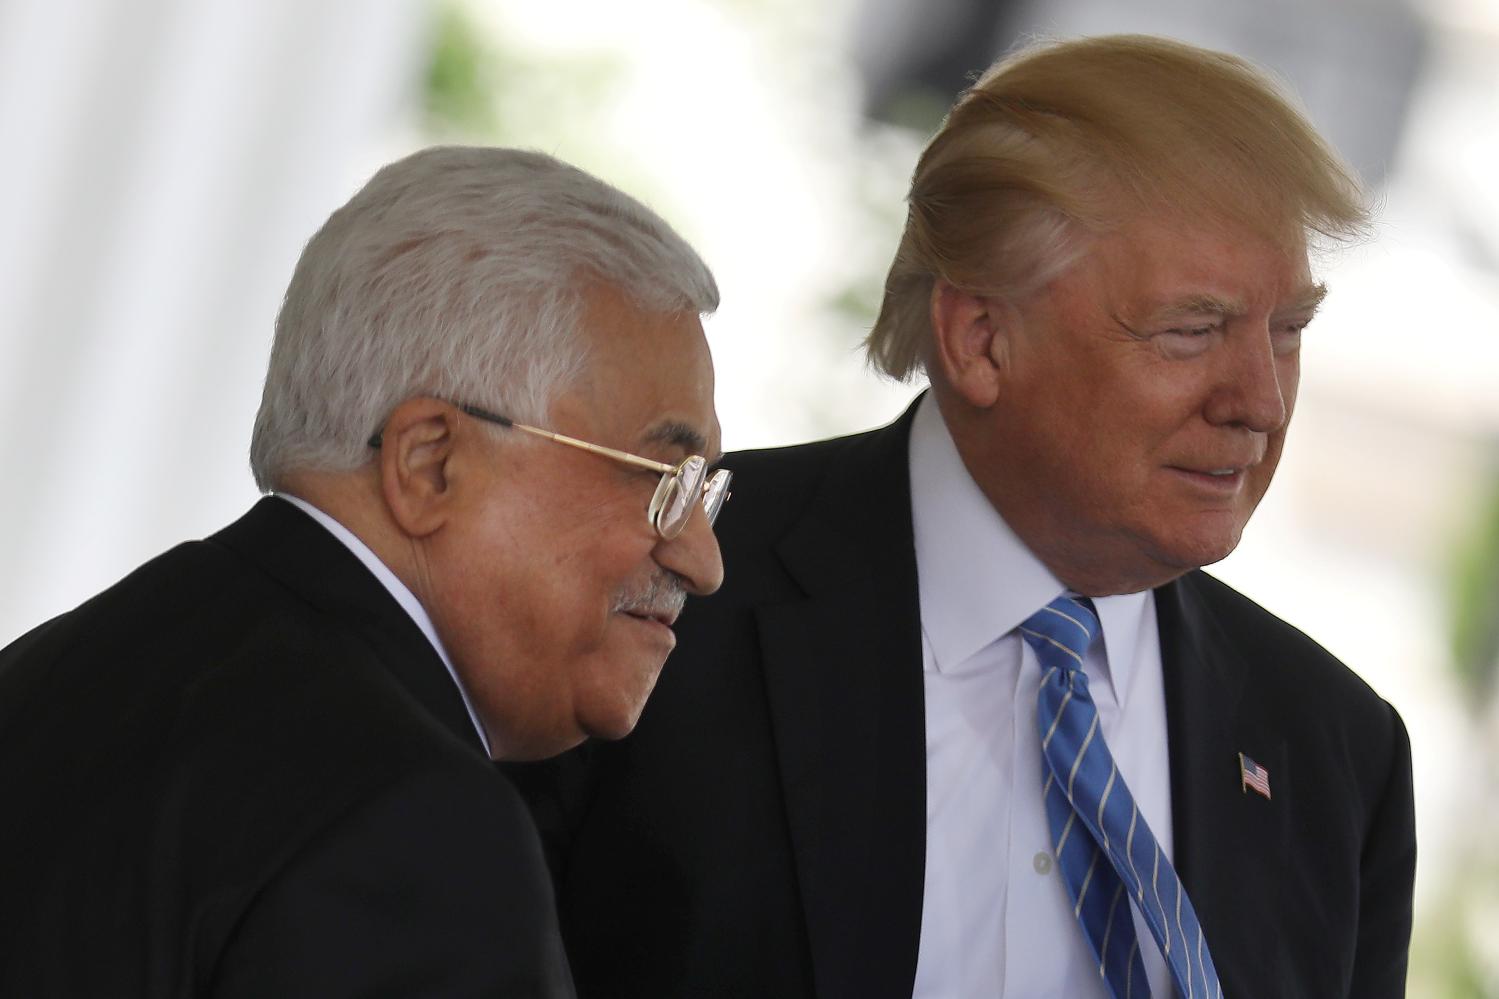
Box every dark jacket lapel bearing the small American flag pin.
[1156,573,1291,995]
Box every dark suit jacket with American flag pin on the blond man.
[519,399,1415,999]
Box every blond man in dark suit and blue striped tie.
[521,38,1415,999]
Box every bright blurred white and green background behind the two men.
[0,0,1499,996]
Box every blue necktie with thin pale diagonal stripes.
[1021,596,1223,999]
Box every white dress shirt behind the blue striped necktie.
[910,395,1172,999]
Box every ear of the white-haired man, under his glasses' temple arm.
[379,399,459,537]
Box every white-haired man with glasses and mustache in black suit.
[0,147,727,998]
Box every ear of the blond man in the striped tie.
[931,278,1015,408]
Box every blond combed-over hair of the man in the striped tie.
[865,35,1369,380]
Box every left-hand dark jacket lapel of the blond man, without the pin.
[757,407,926,999]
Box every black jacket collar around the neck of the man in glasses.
[211,497,484,753]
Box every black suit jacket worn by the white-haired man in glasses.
[0,500,571,999]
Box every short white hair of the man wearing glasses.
[250,146,718,491]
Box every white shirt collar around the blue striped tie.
[910,393,1150,690]
